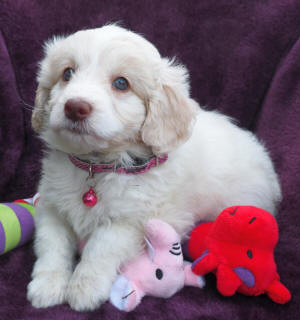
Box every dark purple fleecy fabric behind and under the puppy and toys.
[0,0,300,320]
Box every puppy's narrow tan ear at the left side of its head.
[31,84,50,132]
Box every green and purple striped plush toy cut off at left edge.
[0,194,39,255]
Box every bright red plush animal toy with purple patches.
[188,206,291,304]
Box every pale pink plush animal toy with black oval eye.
[110,219,205,312]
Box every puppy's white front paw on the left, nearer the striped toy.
[27,271,71,308]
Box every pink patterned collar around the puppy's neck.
[68,154,168,176]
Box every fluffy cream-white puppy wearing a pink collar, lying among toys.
[28,25,281,310]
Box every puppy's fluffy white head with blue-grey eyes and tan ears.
[32,25,195,155]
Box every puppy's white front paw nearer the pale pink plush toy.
[67,266,111,311]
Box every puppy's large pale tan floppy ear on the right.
[142,59,196,154]
